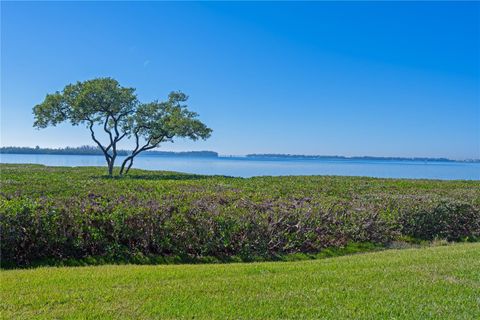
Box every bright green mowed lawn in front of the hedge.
[1,243,480,319]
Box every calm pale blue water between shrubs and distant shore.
[0,154,480,180]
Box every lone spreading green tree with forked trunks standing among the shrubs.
[33,78,212,176]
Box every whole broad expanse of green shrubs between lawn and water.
[0,166,480,267]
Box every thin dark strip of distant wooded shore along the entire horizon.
[0,145,480,162]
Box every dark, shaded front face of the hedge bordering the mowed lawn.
[0,194,480,267]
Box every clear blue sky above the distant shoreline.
[0,2,480,159]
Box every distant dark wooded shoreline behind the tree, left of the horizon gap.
[0,146,218,158]
